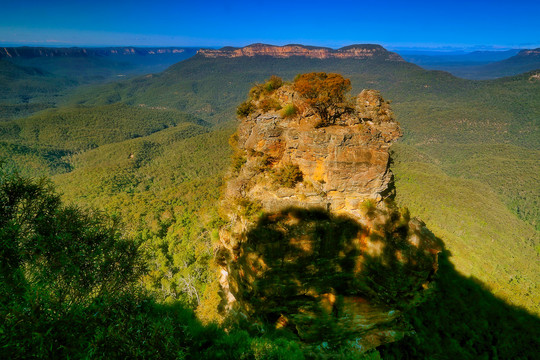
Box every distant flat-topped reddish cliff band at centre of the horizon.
[198,44,404,61]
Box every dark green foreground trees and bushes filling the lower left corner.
[0,173,384,359]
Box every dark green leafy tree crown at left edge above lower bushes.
[0,170,144,308]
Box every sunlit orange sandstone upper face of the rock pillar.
[234,89,401,217]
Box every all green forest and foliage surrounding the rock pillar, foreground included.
[0,52,540,359]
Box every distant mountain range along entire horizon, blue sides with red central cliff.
[0,43,540,80]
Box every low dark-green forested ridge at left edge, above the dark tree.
[0,104,208,176]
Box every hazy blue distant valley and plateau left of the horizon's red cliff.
[0,47,200,121]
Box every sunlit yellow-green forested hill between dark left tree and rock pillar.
[54,124,229,312]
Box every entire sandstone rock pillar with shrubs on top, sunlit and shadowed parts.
[218,73,440,351]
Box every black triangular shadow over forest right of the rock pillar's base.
[378,251,540,360]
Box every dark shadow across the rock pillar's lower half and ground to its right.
[225,208,540,359]
